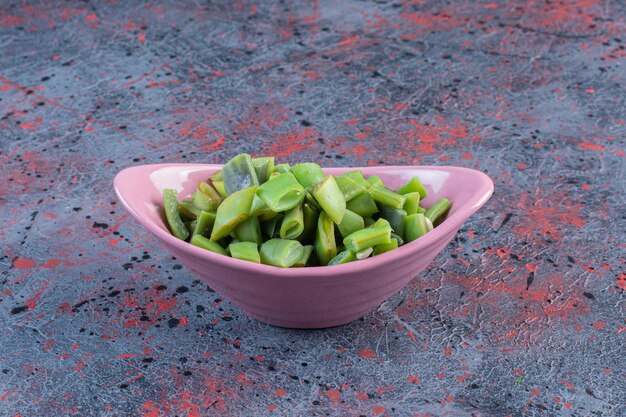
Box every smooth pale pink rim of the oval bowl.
[113,163,494,279]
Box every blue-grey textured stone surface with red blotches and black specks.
[0,0,626,417]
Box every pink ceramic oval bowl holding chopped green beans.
[114,164,493,329]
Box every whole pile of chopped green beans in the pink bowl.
[163,154,450,268]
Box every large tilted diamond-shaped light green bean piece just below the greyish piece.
[211,186,258,241]
